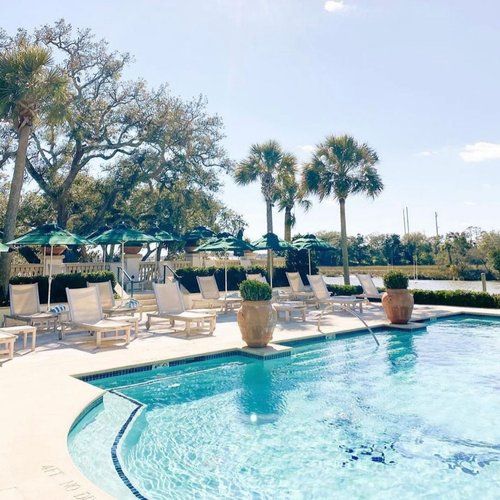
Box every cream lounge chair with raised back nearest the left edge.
[3,283,59,331]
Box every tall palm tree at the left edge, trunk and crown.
[0,41,66,292]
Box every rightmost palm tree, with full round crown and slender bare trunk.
[303,135,384,285]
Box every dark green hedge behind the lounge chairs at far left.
[7,271,116,304]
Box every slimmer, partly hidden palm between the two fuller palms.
[277,155,311,241]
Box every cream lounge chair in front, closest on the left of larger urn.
[146,280,217,337]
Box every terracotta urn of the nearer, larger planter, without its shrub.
[238,300,277,347]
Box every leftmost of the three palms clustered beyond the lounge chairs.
[234,140,293,268]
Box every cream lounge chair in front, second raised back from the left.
[61,286,131,347]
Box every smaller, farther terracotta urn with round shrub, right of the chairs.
[382,271,413,325]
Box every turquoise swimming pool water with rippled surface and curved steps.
[69,317,500,499]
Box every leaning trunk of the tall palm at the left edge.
[0,125,31,296]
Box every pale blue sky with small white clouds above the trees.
[0,0,500,237]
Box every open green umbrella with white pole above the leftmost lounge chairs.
[7,224,93,309]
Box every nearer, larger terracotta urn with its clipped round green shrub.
[237,280,277,347]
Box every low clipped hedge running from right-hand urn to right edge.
[412,290,500,309]
